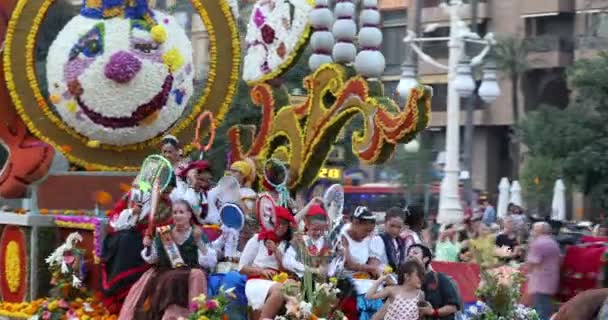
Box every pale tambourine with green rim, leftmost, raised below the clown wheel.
[134,154,173,193]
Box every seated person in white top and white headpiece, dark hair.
[341,207,383,320]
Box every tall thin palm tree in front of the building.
[493,37,530,179]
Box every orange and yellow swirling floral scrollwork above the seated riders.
[229,64,432,190]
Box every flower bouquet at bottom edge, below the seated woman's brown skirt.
[180,287,236,320]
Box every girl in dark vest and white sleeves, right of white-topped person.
[372,207,406,280]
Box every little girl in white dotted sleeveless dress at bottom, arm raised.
[365,259,425,320]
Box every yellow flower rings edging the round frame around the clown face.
[4,0,240,171]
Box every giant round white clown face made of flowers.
[46,0,194,146]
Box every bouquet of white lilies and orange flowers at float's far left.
[46,232,86,301]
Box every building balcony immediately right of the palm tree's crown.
[526,36,574,69]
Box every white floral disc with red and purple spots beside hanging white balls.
[243,0,314,85]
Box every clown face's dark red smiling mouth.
[76,75,173,129]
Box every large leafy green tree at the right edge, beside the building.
[518,54,608,209]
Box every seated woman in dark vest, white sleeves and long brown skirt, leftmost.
[119,200,217,320]
